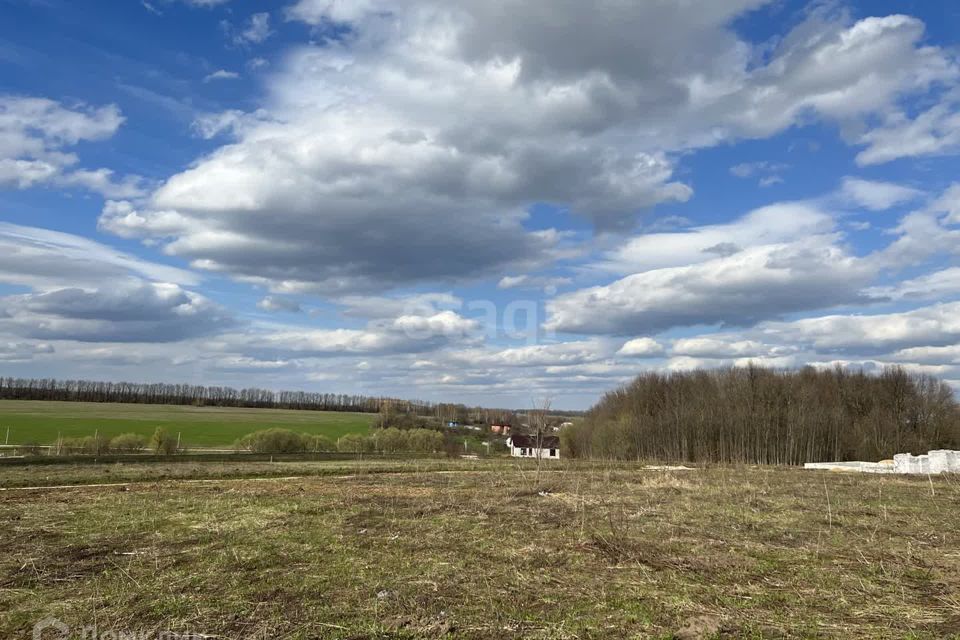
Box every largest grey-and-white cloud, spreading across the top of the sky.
[95,0,954,294]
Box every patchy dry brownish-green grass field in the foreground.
[0,461,960,640]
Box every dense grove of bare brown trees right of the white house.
[561,366,960,464]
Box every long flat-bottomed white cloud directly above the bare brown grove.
[546,235,874,335]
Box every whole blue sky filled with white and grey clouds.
[0,0,960,409]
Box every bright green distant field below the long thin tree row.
[0,400,375,447]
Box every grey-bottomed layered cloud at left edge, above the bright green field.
[0,223,233,342]
